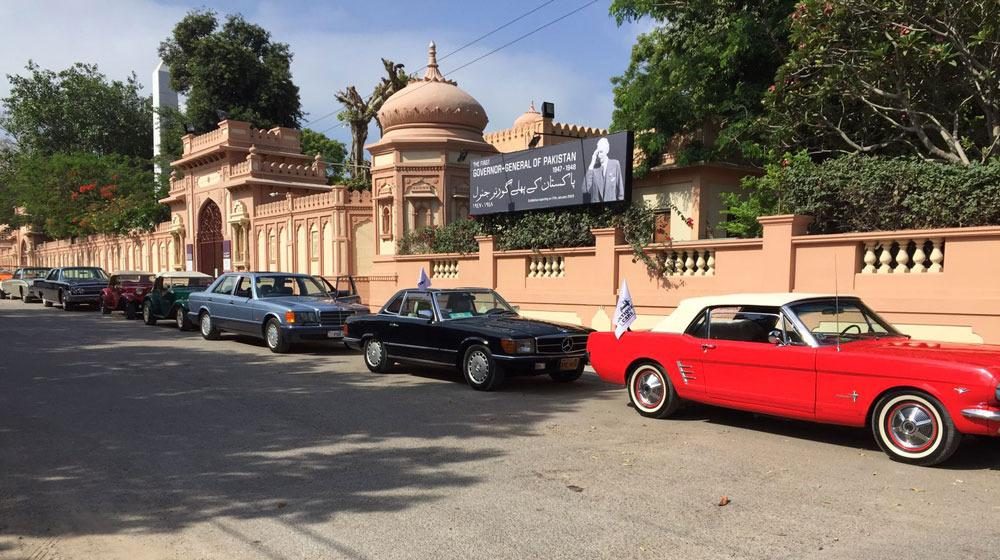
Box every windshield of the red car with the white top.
[789,298,903,345]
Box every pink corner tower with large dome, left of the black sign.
[365,43,497,255]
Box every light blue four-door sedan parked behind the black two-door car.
[188,272,368,353]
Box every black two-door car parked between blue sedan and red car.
[344,288,591,391]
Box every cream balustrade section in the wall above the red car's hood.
[860,237,944,274]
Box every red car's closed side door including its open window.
[701,308,816,418]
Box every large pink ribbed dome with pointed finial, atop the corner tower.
[378,43,489,134]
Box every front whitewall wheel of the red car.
[872,390,962,467]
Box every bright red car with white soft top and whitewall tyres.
[587,293,1000,466]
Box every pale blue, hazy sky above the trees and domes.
[0,0,650,147]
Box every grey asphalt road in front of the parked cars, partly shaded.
[0,301,1000,560]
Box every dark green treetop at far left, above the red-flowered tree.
[0,62,153,158]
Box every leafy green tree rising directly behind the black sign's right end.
[611,0,795,171]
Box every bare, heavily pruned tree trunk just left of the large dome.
[335,58,413,182]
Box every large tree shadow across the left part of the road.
[0,309,613,537]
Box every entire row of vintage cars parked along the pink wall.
[9,267,1000,465]
